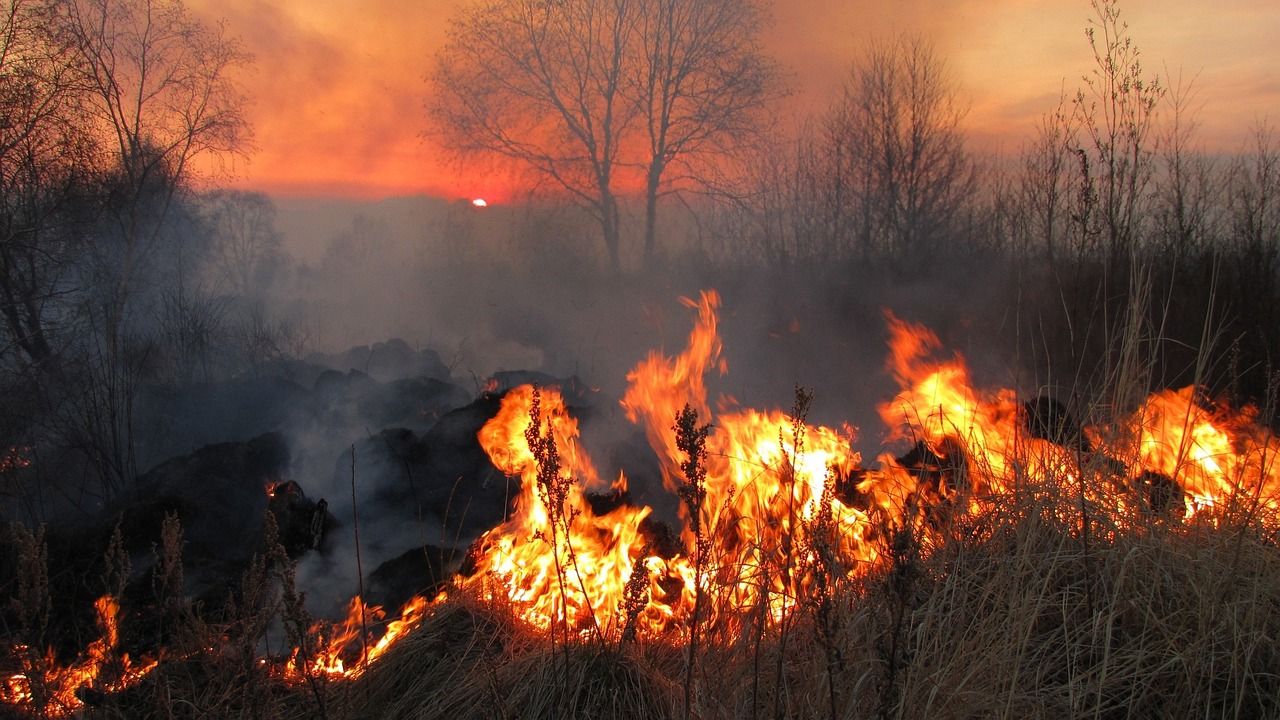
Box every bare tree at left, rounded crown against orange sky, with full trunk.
[50,0,247,492]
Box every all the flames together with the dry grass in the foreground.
[0,291,1280,717]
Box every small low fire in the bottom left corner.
[0,596,157,717]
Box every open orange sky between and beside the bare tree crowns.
[188,0,1280,199]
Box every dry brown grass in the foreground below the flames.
[57,481,1280,719]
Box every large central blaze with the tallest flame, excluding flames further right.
[467,286,876,635]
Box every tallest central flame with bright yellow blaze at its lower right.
[622,291,876,623]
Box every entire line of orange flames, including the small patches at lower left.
[0,291,1280,716]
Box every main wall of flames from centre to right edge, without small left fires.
[450,291,1280,635]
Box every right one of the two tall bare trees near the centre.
[632,0,780,265]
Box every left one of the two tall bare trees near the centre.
[430,0,639,270]
